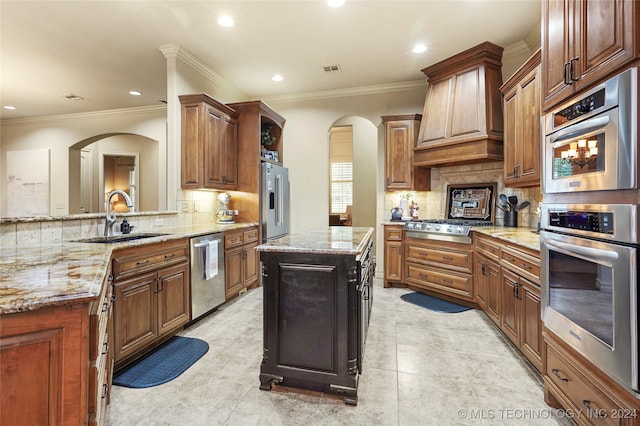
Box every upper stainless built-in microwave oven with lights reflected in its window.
[543,68,638,193]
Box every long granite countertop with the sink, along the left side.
[0,223,257,314]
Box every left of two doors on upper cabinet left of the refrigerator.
[204,105,224,188]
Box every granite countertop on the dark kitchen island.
[257,226,373,255]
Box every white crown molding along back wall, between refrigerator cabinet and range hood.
[260,79,427,103]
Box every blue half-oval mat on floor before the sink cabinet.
[113,336,209,388]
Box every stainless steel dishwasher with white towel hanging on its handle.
[191,233,226,320]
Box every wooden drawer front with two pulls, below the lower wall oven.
[545,345,623,425]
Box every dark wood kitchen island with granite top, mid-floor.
[257,226,375,405]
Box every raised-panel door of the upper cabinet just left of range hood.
[385,121,414,191]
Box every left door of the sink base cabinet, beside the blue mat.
[113,272,158,362]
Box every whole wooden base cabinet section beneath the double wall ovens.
[543,329,640,426]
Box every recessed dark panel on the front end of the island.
[277,265,338,372]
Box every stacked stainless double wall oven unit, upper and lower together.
[540,68,640,398]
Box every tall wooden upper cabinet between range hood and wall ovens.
[500,50,542,187]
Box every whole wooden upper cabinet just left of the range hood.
[382,114,431,191]
